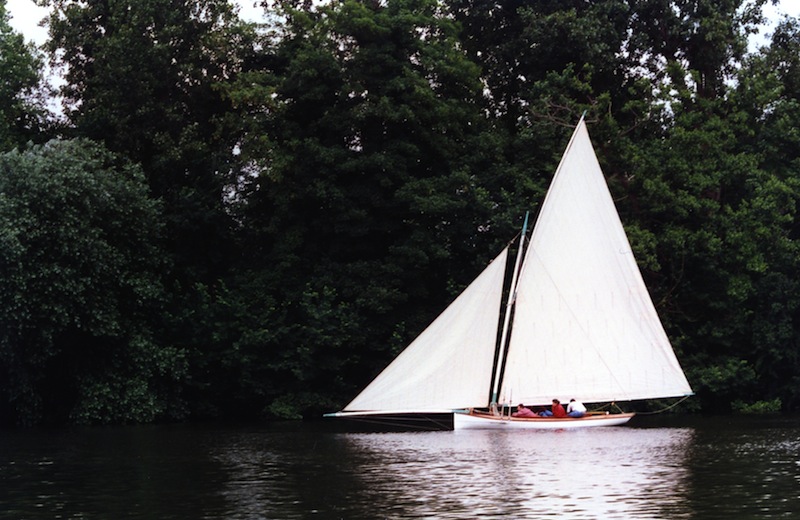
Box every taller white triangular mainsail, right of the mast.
[501,120,691,404]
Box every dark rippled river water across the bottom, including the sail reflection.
[0,416,800,520]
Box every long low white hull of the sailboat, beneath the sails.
[453,413,636,430]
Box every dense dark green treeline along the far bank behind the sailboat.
[0,0,800,425]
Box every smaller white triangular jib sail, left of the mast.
[344,248,508,412]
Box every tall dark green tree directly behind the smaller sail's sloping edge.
[222,0,504,416]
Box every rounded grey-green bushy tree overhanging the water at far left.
[0,140,185,424]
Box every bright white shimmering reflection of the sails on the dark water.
[339,428,693,518]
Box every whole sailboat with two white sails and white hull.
[329,117,692,429]
